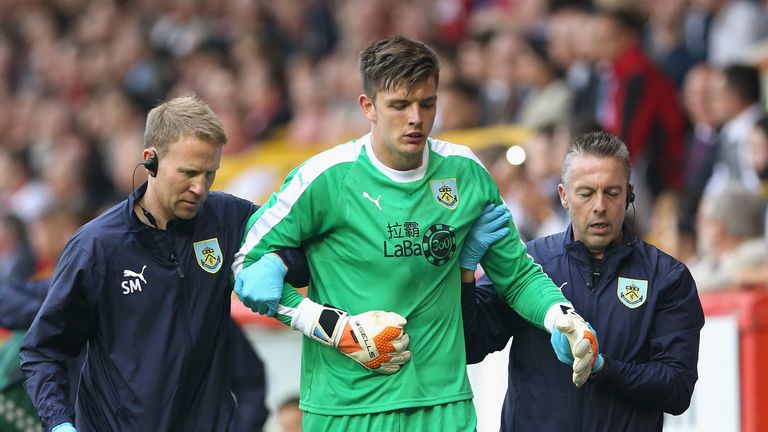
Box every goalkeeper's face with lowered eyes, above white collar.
[358,78,437,171]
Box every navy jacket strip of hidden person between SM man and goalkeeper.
[229,319,269,432]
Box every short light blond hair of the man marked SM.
[144,94,227,156]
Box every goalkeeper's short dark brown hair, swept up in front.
[360,36,440,99]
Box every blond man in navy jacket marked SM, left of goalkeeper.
[16,96,302,432]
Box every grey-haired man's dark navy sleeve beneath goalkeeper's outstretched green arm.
[461,276,527,364]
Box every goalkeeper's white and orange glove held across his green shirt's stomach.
[291,299,411,375]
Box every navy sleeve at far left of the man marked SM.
[20,242,99,430]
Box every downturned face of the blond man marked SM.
[145,137,221,221]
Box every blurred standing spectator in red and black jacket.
[592,10,685,199]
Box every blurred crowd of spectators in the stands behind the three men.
[0,0,768,310]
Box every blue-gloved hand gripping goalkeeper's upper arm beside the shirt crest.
[459,204,512,271]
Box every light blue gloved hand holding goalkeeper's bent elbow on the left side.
[234,253,288,316]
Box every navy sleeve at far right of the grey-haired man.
[592,264,704,415]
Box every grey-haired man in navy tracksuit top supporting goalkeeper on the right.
[462,133,704,432]
